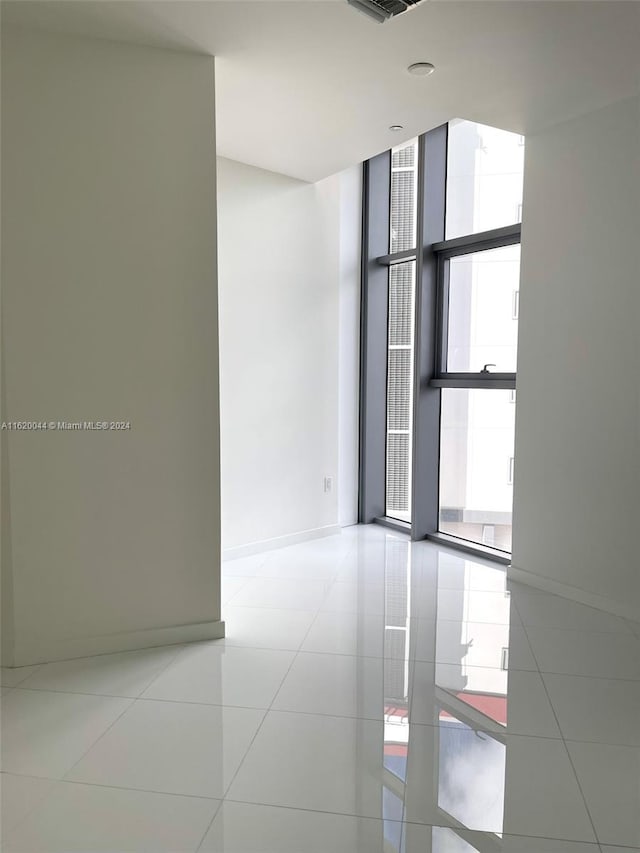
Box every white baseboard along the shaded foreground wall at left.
[13,621,224,666]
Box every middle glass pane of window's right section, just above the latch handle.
[446,244,520,373]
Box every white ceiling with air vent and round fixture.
[2,0,640,181]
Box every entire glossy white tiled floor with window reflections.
[2,526,640,853]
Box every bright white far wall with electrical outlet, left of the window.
[218,158,359,553]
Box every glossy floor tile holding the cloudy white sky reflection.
[404,720,596,842]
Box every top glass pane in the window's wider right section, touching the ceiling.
[445,119,524,239]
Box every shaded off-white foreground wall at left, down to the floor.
[2,28,223,665]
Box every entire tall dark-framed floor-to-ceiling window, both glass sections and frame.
[361,120,524,552]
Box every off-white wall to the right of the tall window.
[513,98,640,618]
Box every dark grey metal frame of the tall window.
[359,124,522,563]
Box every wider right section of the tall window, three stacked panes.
[436,121,524,552]
